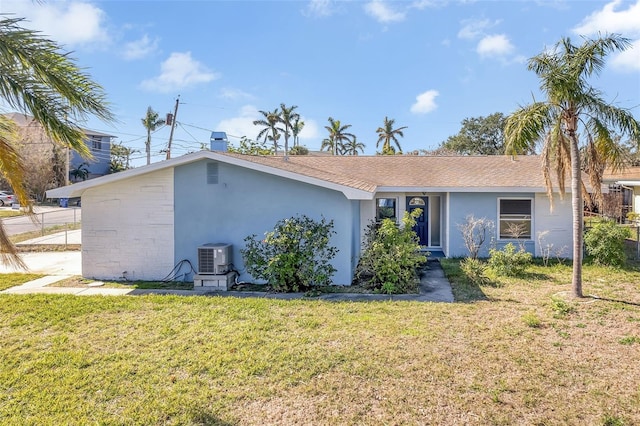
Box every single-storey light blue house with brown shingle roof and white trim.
[47,147,572,285]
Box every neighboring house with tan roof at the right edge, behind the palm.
[602,166,640,221]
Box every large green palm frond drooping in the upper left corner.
[0,18,114,157]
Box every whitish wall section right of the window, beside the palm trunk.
[531,193,573,257]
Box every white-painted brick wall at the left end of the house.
[82,168,174,281]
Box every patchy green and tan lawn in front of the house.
[0,260,640,425]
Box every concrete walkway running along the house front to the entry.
[0,258,453,303]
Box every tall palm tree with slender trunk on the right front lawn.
[505,35,640,297]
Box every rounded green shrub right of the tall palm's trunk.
[584,220,630,266]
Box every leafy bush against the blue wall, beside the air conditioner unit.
[240,215,338,292]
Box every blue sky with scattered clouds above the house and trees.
[0,0,640,165]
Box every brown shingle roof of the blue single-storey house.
[224,153,556,191]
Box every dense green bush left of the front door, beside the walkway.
[356,209,427,294]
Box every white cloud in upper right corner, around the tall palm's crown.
[573,0,640,71]
